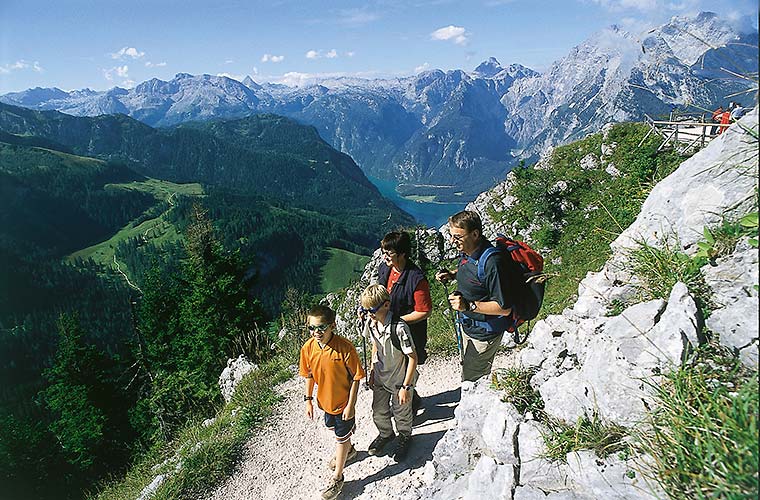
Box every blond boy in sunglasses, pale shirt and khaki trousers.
[361,284,417,462]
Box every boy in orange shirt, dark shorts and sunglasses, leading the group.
[299,305,364,500]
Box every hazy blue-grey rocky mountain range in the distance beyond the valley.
[0,13,758,201]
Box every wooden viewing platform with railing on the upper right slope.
[639,114,728,154]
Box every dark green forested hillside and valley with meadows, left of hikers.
[0,105,413,498]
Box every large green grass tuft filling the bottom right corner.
[638,345,760,500]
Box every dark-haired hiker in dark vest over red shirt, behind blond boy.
[377,231,433,414]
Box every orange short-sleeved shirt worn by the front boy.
[298,334,364,415]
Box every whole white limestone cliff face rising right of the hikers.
[418,108,758,499]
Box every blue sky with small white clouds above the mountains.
[0,0,758,94]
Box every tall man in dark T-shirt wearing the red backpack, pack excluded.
[436,211,524,381]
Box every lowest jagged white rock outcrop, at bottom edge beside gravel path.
[416,377,663,500]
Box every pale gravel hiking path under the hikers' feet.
[208,353,507,500]
